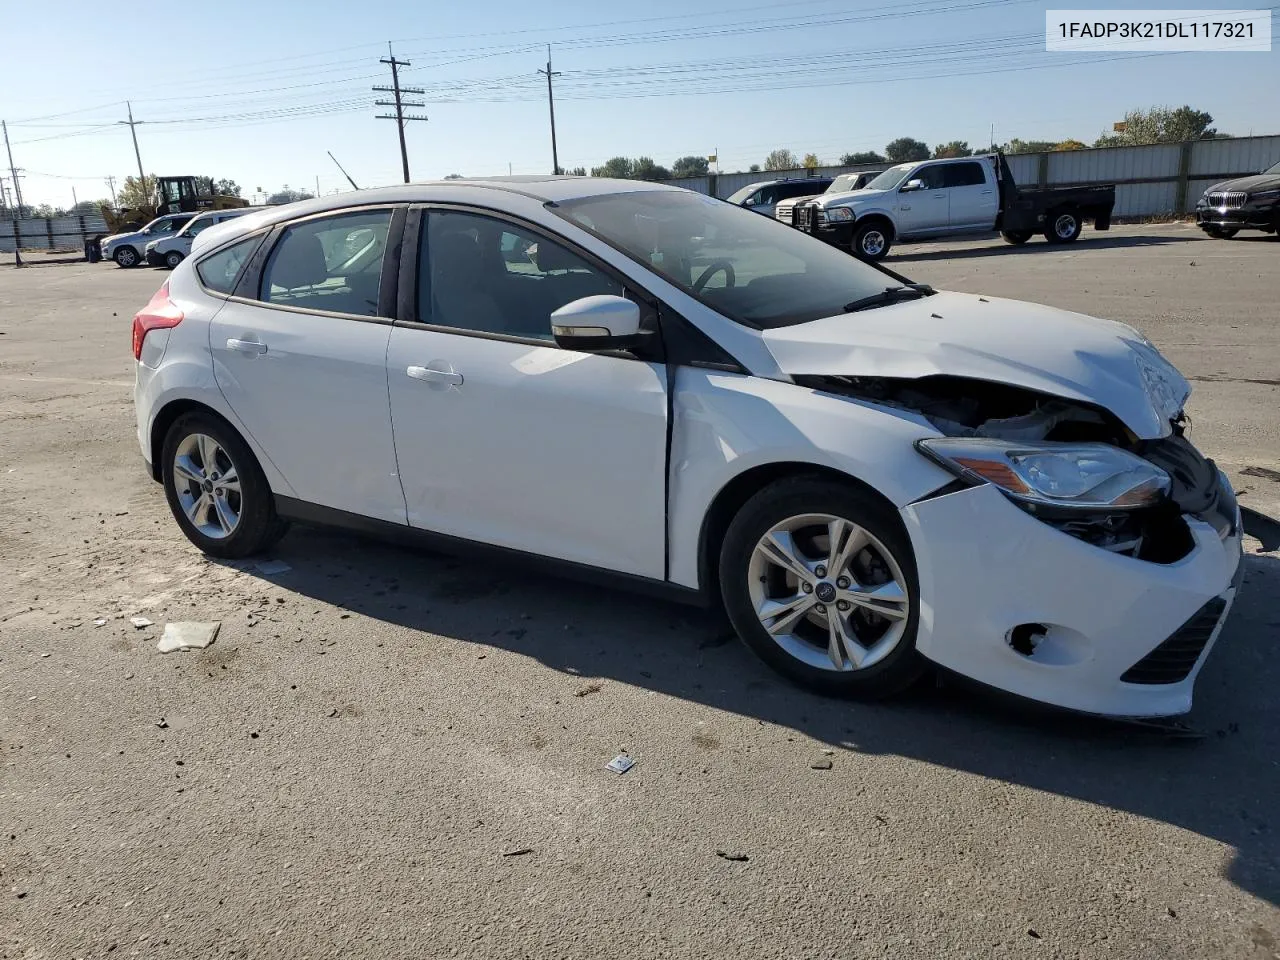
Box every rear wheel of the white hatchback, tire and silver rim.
[161,412,287,559]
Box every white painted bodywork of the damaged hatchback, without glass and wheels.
[134,178,1240,716]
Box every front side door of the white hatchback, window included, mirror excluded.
[387,209,667,579]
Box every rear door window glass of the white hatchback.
[261,210,392,316]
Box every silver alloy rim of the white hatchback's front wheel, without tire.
[748,513,911,672]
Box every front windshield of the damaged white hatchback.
[550,189,895,329]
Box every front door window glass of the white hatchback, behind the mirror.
[417,211,625,342]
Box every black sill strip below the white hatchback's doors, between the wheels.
[275,494,709,607]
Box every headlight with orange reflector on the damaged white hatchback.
[915,436,1170,511]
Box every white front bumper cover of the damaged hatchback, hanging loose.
[902,477,1243,717]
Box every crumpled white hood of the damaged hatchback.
[763,293,1190,439]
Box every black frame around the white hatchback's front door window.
[394,201,673,364]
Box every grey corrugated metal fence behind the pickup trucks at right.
[668,136,1280,218]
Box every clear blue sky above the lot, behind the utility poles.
[0,0,1280,206]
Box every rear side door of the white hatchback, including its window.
[207,206,404,524]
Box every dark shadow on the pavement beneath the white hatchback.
[227,527,1280,904]
